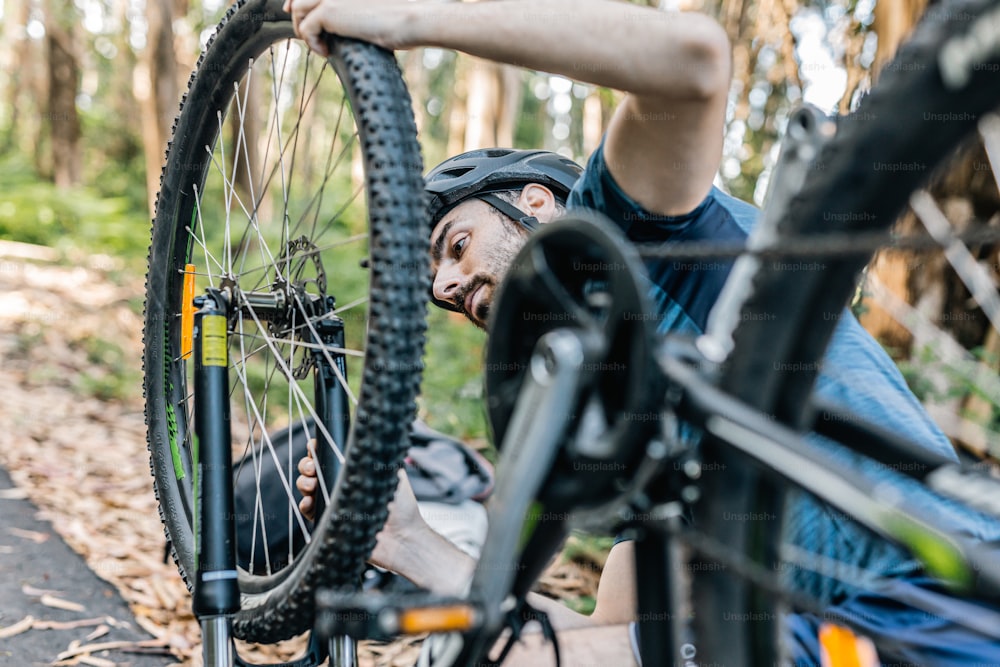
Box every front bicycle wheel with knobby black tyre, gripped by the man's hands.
[143,0,429,643]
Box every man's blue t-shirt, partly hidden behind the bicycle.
[567,143,1000,664]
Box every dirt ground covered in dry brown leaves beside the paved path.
[0,241,596,667]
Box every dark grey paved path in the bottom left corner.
[0,468,177,667]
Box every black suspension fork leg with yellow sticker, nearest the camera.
[193,289,240,667]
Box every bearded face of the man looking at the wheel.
[431,199,527,329]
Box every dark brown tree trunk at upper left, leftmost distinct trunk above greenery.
[45,0,82,188]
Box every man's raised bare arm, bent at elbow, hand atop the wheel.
[288,0,731,215]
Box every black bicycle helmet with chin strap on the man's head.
[424,148,583,312]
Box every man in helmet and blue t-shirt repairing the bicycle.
[286,0,997,665]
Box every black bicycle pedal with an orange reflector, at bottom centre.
[315,589,483,641]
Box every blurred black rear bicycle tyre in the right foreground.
[691,0,1000,665]
